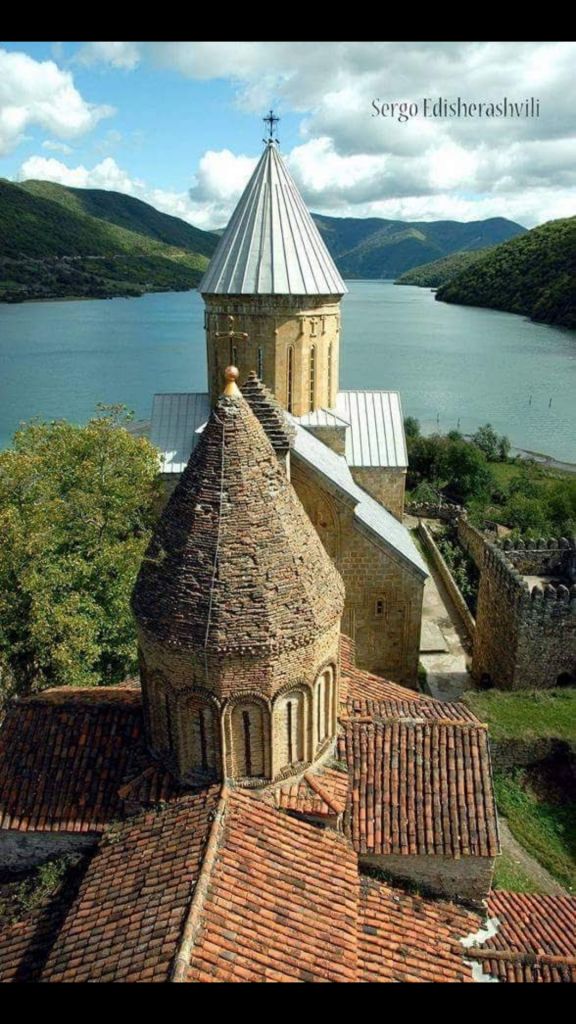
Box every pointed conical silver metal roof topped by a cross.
[199,142,347,295]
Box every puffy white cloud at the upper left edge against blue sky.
[0,49,114,156]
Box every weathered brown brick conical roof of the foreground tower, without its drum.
[132,376,344,653]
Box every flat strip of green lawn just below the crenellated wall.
[461,687,576,740]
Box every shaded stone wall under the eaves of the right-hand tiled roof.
[359,854,494,904]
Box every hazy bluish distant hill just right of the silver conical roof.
[314,214,526,279]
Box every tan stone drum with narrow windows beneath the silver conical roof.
[204,295,340,416]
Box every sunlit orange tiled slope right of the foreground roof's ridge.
[187,790,358,981]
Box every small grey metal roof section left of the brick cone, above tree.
[150,393,210,473]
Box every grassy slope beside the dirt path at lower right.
[487,769,576,893]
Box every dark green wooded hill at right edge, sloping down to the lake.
[436,217,576,328]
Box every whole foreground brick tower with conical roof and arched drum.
[132,368,344,785]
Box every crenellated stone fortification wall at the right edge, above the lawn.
[472,538,576,690]
